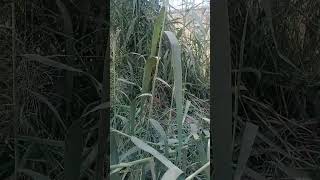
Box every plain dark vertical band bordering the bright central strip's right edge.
[210,0,232,180]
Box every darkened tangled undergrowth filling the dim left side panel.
[0,0,106,179]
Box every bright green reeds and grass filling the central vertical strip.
[110,0,210,179]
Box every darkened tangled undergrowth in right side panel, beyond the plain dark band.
[229,0,320,179]
